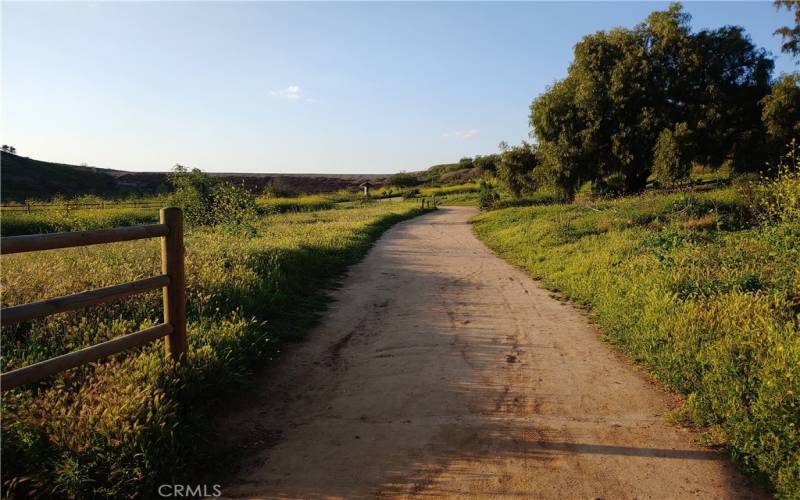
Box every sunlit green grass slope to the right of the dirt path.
[474,184,800,498]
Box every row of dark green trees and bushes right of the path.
[473,0,800,199]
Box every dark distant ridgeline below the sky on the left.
[0,151,388,203]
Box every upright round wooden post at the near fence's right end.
[159,207,186,361]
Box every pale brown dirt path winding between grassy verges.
[221,207,762,499]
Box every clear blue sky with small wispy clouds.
[0,2,797,173]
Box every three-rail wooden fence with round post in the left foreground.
[0,208,186,390]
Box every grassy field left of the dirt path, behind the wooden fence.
[2,202,428,498]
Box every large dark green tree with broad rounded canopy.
[530,4,773,199]
